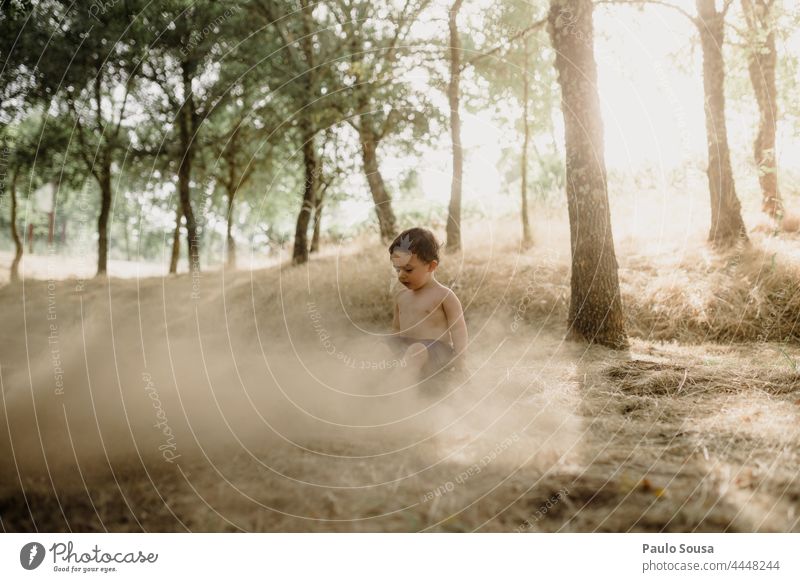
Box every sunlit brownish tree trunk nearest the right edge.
[742,0,783,220]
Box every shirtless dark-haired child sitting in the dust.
[389,228,467,378]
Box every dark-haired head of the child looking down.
[389,228,439,291]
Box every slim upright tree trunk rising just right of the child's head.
[445,0,464,252]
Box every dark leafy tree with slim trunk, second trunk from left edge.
[5,0,142,275]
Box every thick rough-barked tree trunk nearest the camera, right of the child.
[548,0,628,348]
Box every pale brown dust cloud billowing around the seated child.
[0,264,580,492]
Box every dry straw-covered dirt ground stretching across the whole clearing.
[0,222,800,532]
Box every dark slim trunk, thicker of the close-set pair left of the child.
[178,65,200,273]
